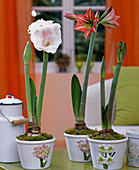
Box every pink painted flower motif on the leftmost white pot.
[33,144,50,167]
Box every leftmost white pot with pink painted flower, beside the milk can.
[16,138,55,169]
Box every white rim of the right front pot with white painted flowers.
[87,137,128,144]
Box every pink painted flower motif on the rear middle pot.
[77,139,91,160]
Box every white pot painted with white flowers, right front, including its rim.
[88,137,128,169]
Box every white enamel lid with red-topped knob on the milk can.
[0,94,23,105]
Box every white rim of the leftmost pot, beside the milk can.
[16,136,55,145]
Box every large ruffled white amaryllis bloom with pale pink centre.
[28,19,62,54]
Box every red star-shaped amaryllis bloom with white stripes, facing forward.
[74,8,99,39]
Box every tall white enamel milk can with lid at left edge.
[0,95,25,163]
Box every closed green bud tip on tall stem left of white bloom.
[23,41,32,64]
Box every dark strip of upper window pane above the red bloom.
[74,0,105,6]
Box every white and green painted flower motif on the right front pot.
[98,145,116,169]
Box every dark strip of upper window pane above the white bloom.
[33,0,62,6]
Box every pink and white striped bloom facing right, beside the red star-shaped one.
[98,6,120,29]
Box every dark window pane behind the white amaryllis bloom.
[34,12,62,62]
